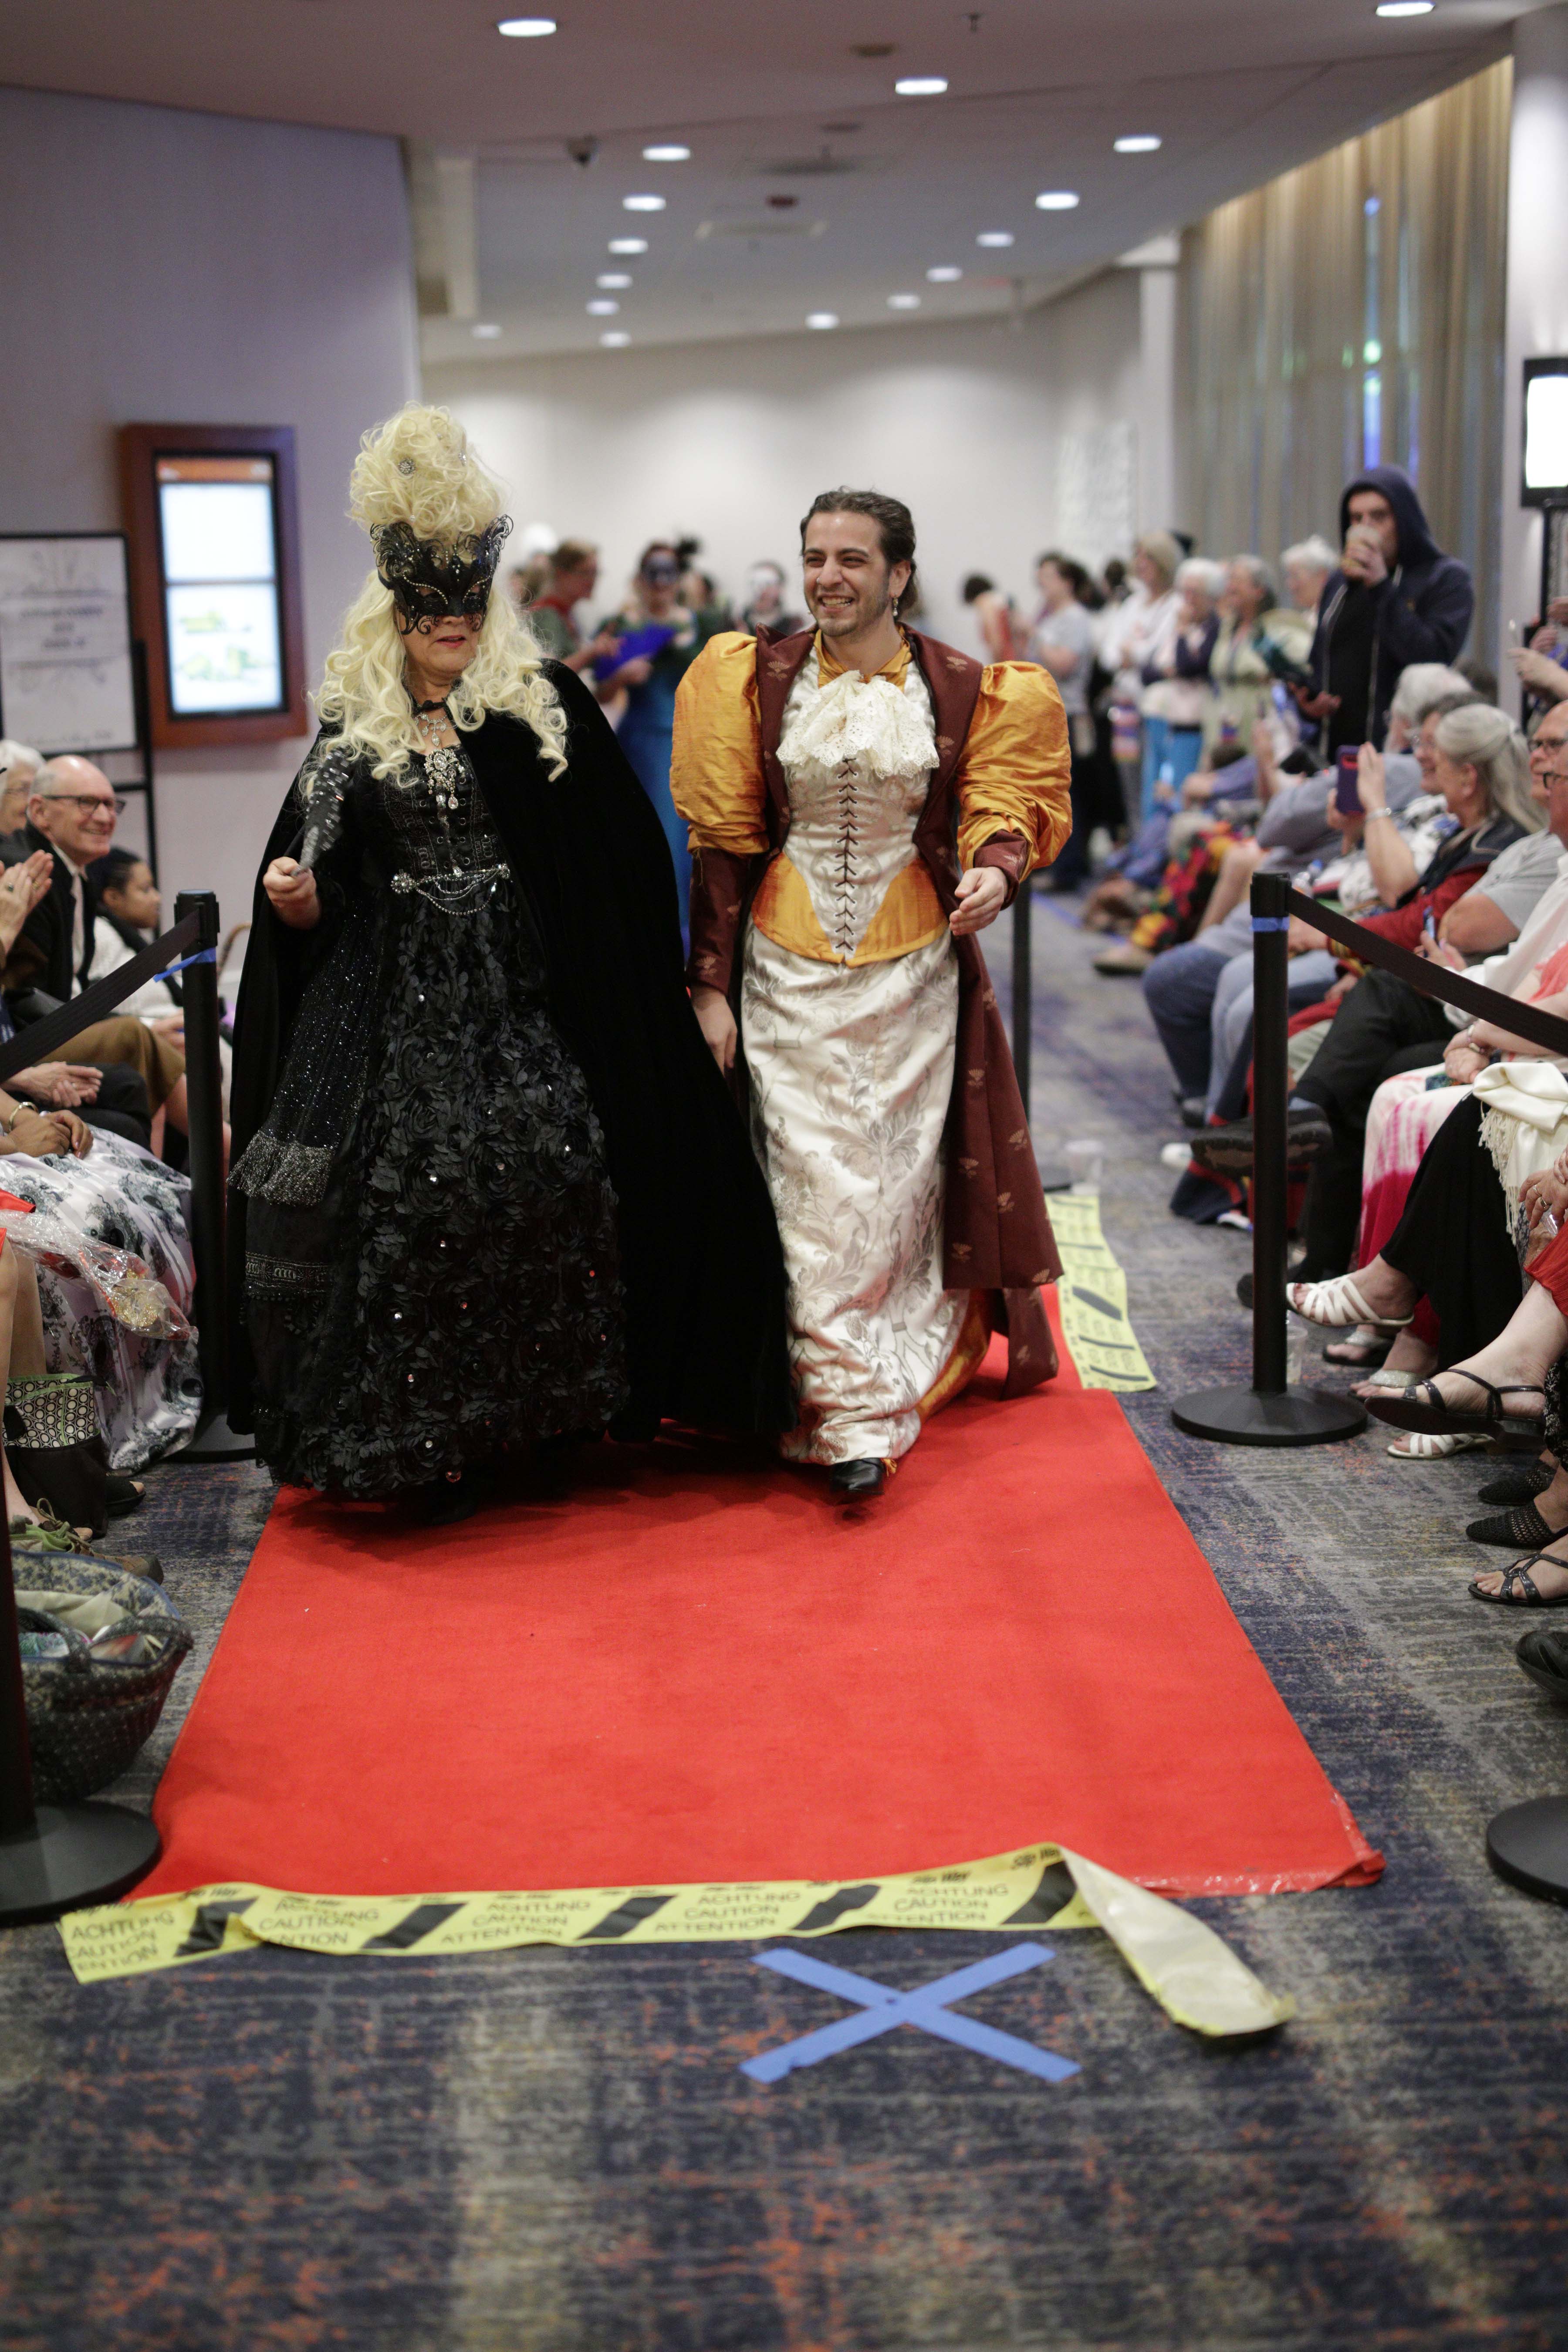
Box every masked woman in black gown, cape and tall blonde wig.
[230,407,790,1517]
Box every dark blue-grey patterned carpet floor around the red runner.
[0,901,1568,2352]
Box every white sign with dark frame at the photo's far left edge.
[0,531,141,757]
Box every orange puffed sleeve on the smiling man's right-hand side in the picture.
[957,661,1072,868]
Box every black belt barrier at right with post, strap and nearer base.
[1171,875,1568,1903]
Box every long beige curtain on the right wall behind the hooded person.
[1178,59,1511,661]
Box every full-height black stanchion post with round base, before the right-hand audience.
[1171,875,1366,1446]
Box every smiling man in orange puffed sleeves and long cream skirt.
[670,489,1070,1500]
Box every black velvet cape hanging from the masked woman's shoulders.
[228,663,794,1437]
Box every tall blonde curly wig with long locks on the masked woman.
[315,400,567,783]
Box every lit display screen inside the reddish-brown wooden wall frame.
[158,456,284,717]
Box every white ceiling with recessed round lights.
[0,0,1547,360]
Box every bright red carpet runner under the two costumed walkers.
[139,1308,1380,1893]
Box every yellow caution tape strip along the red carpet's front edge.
[59,1846,1295,2034]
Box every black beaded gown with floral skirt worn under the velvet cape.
[233,750,628,1498]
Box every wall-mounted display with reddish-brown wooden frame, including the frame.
[120,426,308,750]
